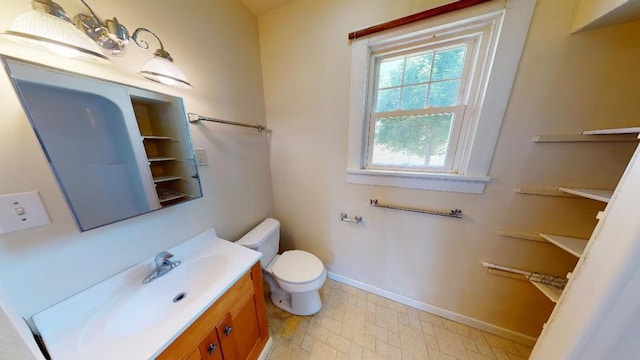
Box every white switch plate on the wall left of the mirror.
[0,191,51,234]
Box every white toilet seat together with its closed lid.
[269,250,327,293]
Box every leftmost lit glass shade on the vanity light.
[4,10,108,60]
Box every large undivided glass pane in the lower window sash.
[371,114,454,167]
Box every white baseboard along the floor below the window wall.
[327,272,537,345]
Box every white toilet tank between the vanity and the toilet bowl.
[236,218,280,269]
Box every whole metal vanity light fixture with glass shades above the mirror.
[4,0,193,88]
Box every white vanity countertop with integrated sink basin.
[33,229,262,360]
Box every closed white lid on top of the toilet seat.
[271,250,324,284]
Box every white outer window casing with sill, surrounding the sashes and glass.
[347,0,536,194]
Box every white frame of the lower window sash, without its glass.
[365,105,466,173]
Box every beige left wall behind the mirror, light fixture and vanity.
[0,0,273,320]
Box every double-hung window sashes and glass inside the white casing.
[366,39,476,172]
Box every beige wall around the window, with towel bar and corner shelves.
[259,0,640,336]
